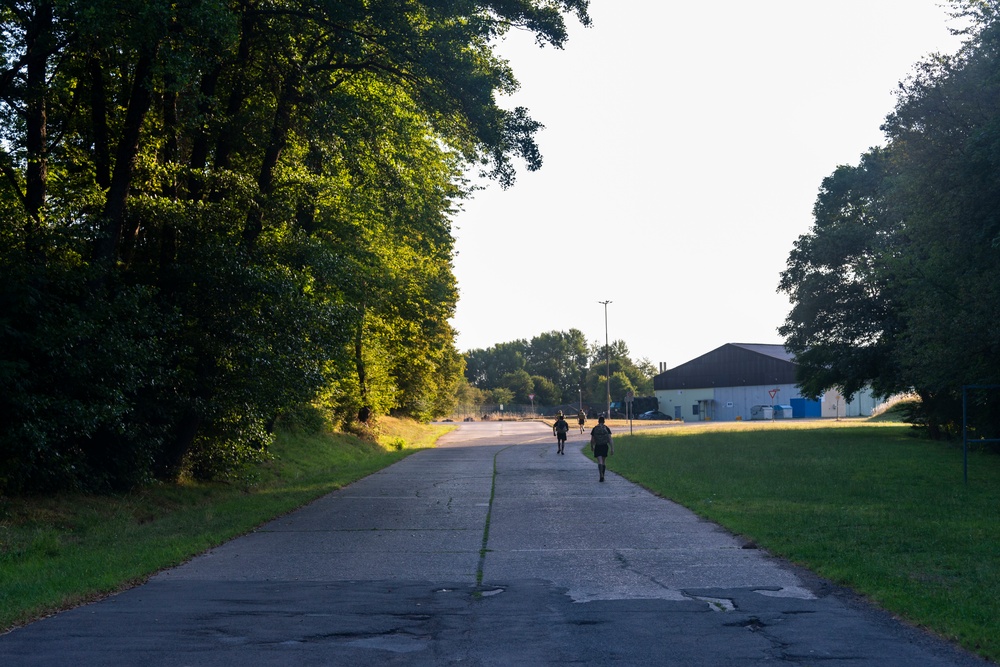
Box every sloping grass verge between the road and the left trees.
[0,418,450,632]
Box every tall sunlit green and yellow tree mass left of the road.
[0,0,589,491]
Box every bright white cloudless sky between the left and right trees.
[452,0,959,368]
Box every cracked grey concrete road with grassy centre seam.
[0,423,986,667]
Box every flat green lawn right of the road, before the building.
[610,421,1000,661]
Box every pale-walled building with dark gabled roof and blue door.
[653,343,875,421]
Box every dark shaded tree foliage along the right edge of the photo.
[779,0,1000,437]
